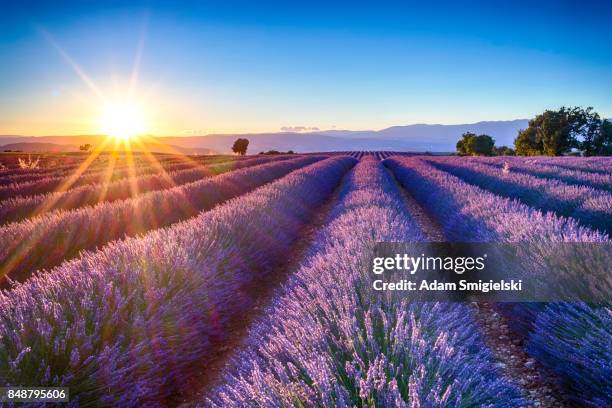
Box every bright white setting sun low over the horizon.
[99,101,148,140]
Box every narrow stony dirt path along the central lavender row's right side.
[387,170,570,408]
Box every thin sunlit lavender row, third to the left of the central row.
[0,156,290,224]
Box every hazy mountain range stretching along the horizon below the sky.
[0,119,528,154]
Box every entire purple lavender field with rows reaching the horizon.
[0,151,612,407]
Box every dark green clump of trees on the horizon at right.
[457,107,612,156]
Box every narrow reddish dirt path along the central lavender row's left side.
[173,170,351,408]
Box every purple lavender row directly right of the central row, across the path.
[386,159,612,406]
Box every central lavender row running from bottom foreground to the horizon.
[207,157,525,407]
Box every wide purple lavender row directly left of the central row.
[0,157,355,406]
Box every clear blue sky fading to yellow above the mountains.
[0,0,612,135]
